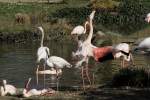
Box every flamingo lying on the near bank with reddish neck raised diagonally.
[23,78,55,97]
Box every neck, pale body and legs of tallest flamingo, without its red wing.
[73,10,96,90]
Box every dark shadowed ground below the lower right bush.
[82,87,150,100]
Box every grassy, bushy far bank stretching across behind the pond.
[0,0,150,41]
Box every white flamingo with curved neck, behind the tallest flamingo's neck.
[71,21,89,35]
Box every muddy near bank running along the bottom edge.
[0,87,150,100]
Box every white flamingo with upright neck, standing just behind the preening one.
[37,27,50,62]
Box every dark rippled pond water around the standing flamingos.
[0,42,150,87]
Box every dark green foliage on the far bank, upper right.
[96,0,148,34]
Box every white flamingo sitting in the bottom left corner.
[0,80,17,96]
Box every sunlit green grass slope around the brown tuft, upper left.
[0,0,88,32]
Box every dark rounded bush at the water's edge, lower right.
[111,68,150,87]
